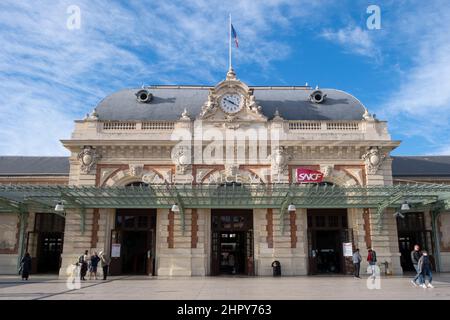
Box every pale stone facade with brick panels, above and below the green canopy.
[0,73,450,276]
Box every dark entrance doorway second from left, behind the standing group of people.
[110,209,156,275]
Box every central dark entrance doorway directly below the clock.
[211,209,254,275]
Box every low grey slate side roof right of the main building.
[392,156,450,177]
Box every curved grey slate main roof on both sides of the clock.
[96,86,365,121]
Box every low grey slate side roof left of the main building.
[0,156,69,176]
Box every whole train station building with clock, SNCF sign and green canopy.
[0,69,450,276]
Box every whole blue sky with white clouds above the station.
[0,0,450,155]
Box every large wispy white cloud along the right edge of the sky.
[380,2,450,154]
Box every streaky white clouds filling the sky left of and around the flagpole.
[0,0,320,155]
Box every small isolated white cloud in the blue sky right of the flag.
[321,26,379,57]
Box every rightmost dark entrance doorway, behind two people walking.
[397,212,435,272]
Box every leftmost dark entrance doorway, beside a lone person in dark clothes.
[26,213,65,273]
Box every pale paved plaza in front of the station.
[0,273,450,300]
